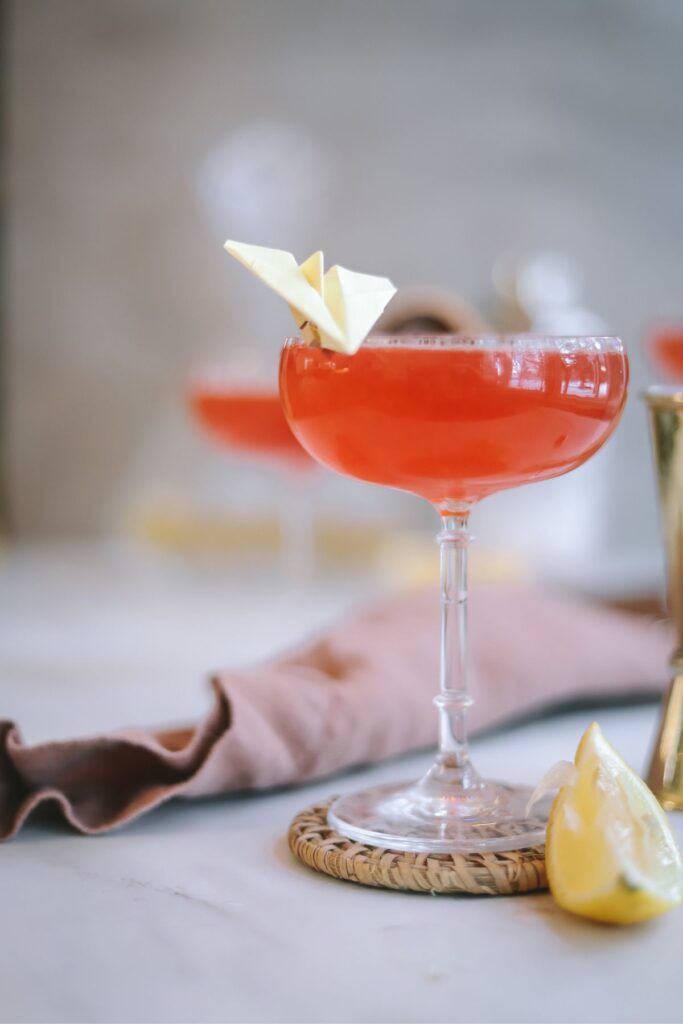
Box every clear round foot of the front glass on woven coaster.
[328,781,551,853]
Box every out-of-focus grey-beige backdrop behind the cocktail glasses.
[2,0,683,596]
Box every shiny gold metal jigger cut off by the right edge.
[643,387,683,810]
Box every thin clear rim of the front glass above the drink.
[285,331,625,354]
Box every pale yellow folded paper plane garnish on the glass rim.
[225,241,396,354]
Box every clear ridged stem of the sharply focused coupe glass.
[434,509,478,785]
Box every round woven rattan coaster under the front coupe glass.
[288,800,548,896]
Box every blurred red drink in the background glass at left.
[189,384,310,465]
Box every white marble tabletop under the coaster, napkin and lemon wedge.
[0,548,683,1022]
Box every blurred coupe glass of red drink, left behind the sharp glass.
[189,368,316,582]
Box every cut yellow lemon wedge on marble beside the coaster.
[546,722,683,925]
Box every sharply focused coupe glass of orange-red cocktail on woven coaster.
[280,335,628,852]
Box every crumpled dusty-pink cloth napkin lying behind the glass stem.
[0,587,673,839]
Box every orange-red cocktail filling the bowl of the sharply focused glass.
[281,342,628,505]
